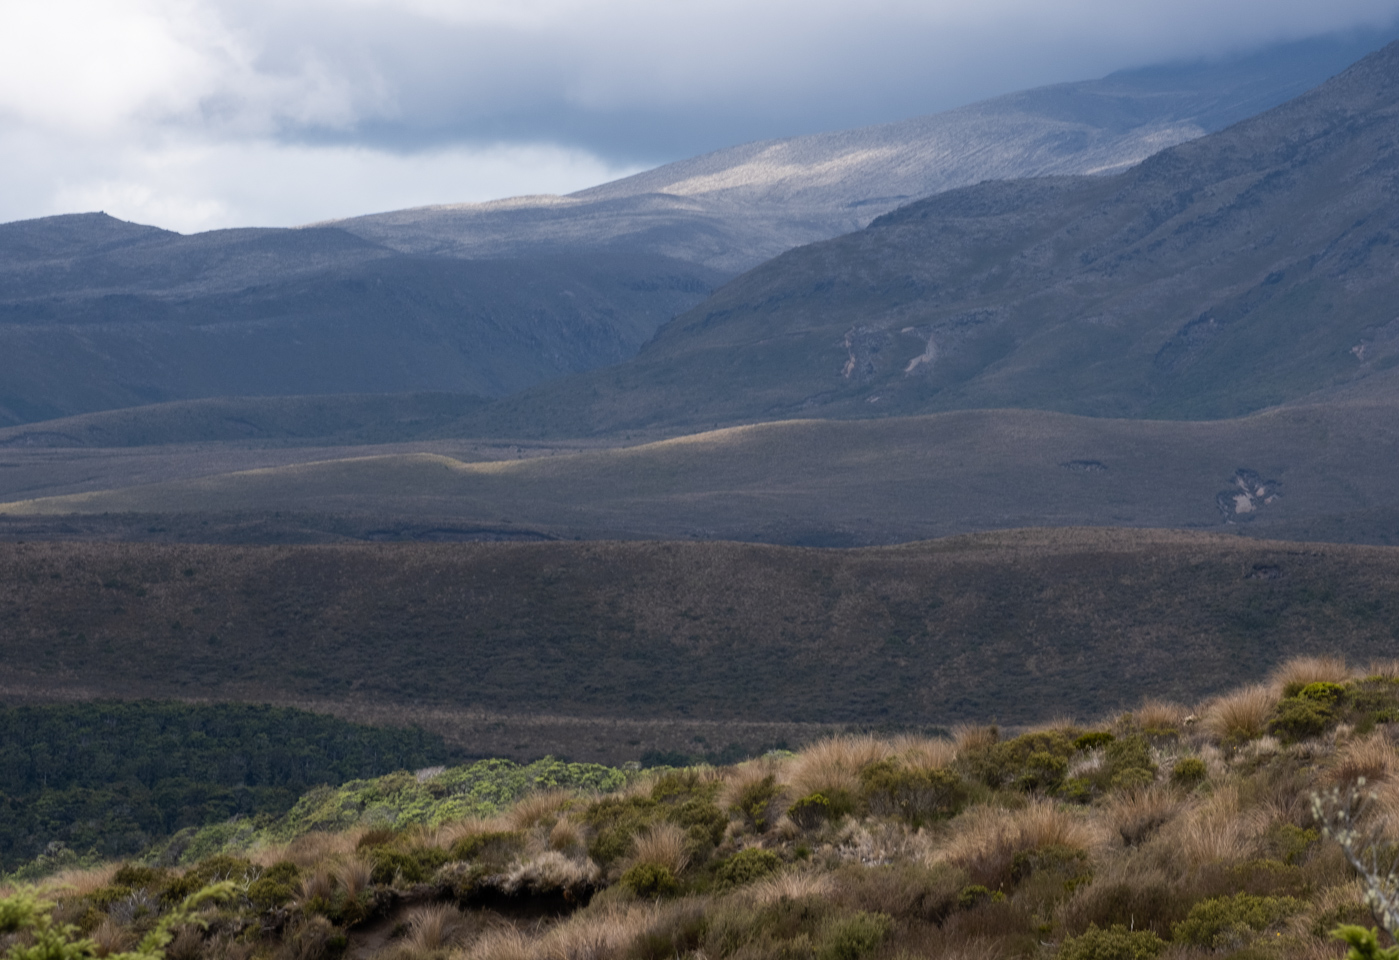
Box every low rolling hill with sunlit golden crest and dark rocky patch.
[0,400,1399,546]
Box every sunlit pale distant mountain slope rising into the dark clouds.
[337,29,1393,273]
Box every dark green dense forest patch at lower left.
[0,703,460,872]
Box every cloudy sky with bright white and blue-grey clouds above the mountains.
[0,0,1399,232]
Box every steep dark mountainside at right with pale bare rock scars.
[475,45,1399,434]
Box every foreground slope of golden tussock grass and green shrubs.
[7,659,1399,960]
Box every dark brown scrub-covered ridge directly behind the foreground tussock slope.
[0,529,1399,738]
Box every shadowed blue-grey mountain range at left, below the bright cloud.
[0,214,719,423]
